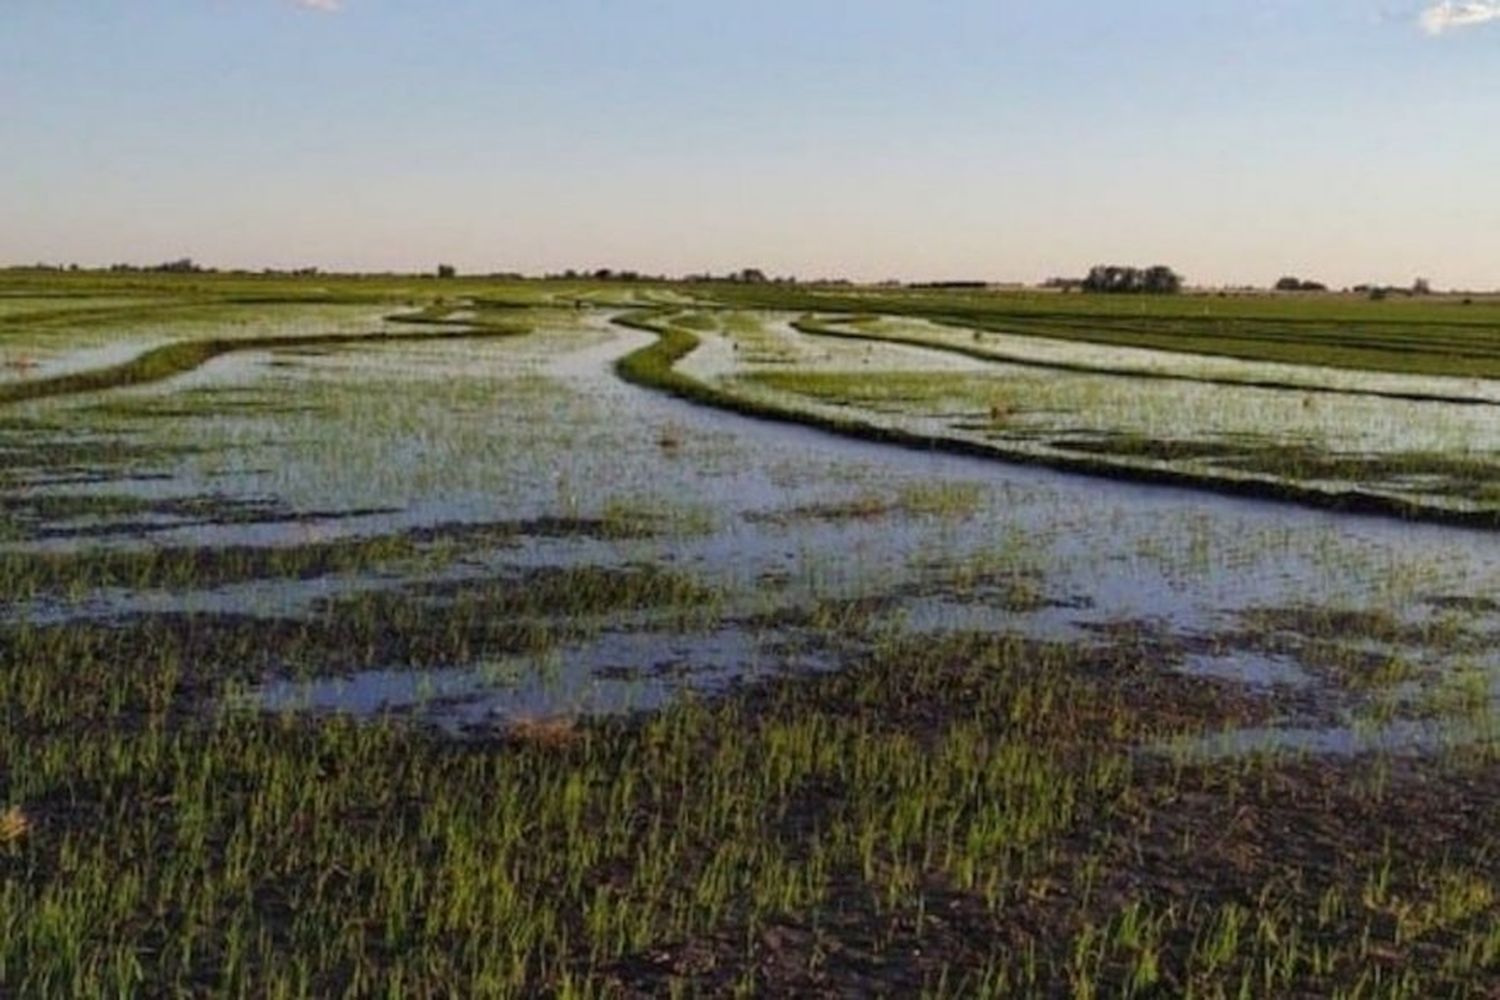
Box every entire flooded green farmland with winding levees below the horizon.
[0,271,1500,997]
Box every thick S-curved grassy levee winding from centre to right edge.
[615,313,1500,528]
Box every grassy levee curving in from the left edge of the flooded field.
[0,321,527,405]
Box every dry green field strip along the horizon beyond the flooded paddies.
[11,271,1500,378]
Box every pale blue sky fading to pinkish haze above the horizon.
[0,0,1500,288]
